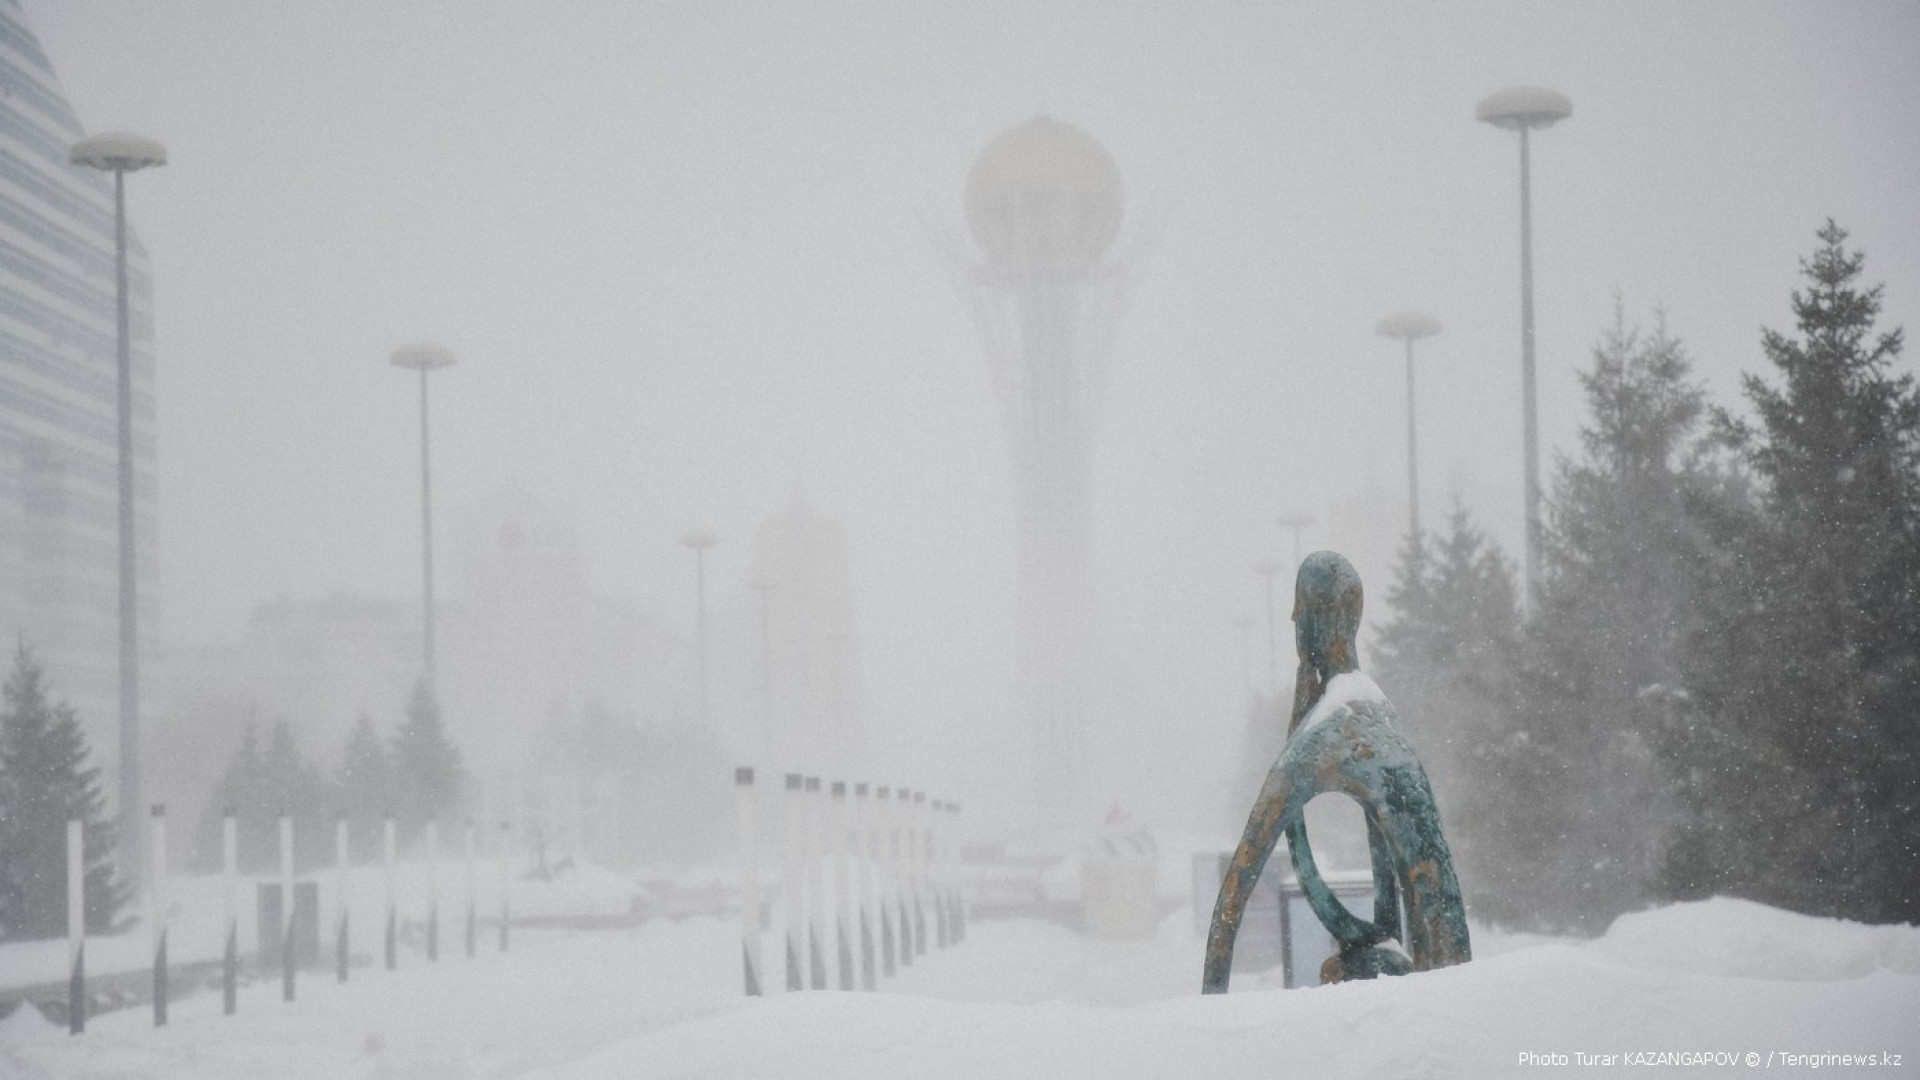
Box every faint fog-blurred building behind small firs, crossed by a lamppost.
[154,488,693,841]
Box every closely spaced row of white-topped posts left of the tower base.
[733,767,966,995]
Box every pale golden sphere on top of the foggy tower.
[966,113,1123,273]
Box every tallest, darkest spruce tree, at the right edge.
[1701,221,1920,920]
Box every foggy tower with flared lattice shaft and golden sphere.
[962,115,1125,822]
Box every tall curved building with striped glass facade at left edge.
[0,0,159,757]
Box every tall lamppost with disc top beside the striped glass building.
[67,131,167,882]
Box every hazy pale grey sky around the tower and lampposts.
[27,0,1920,818]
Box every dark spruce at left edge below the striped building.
[0,642,129,940]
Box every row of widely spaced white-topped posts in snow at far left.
[67,803,513,1034]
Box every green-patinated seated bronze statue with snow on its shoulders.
[1200,552,1473,994]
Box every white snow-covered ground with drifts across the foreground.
[0,876,1920,1080]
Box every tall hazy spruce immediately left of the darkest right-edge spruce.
[1517,300,1713,932]
